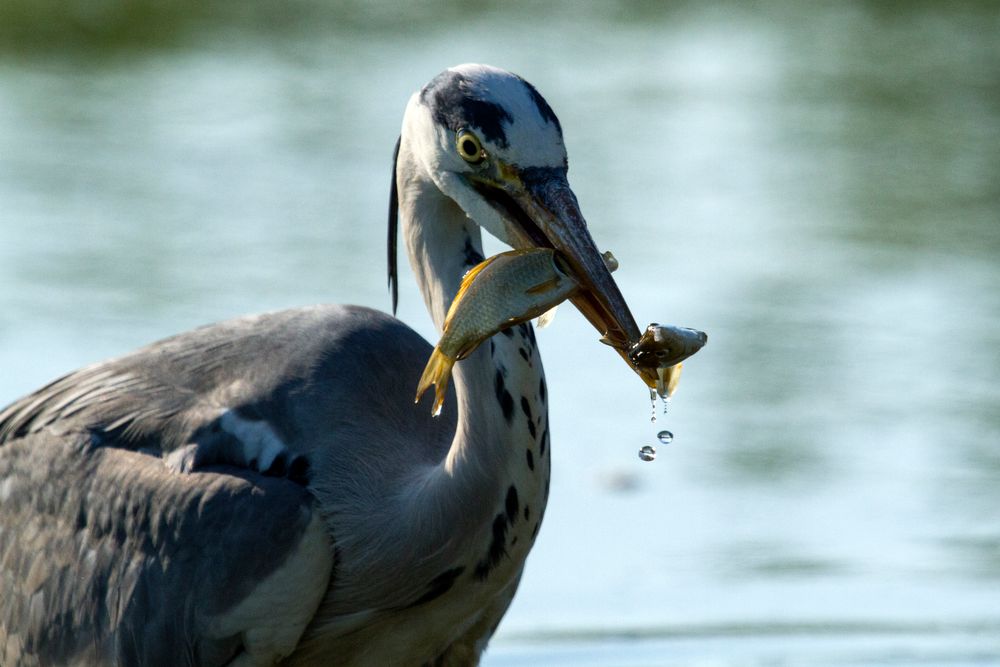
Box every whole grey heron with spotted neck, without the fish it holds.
[0,65,639,667]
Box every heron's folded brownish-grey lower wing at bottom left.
[0,430,333,667]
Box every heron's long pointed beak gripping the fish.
[477,168,655,384]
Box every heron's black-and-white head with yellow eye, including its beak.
[394,65,639,351]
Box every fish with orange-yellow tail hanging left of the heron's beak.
[415,248,579,415]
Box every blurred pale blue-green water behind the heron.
[0,0,1000,667]
